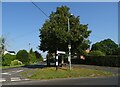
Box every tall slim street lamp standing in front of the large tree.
[67,14,73,70]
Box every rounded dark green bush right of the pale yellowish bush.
[16,50,30,65]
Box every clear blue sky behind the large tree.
[2,2,118,57]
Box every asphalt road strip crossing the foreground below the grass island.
[4,77,118,85]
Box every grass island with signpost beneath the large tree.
[22,67,114,79]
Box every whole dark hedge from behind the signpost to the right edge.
[47,55,120,67]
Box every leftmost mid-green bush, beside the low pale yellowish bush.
[2,53,16,66]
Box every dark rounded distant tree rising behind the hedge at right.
[91,39,118,55]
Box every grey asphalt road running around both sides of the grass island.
[0,63,118,85]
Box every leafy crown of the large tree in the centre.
[39,6,91,53]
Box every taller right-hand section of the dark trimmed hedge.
[85,55,120,67]
